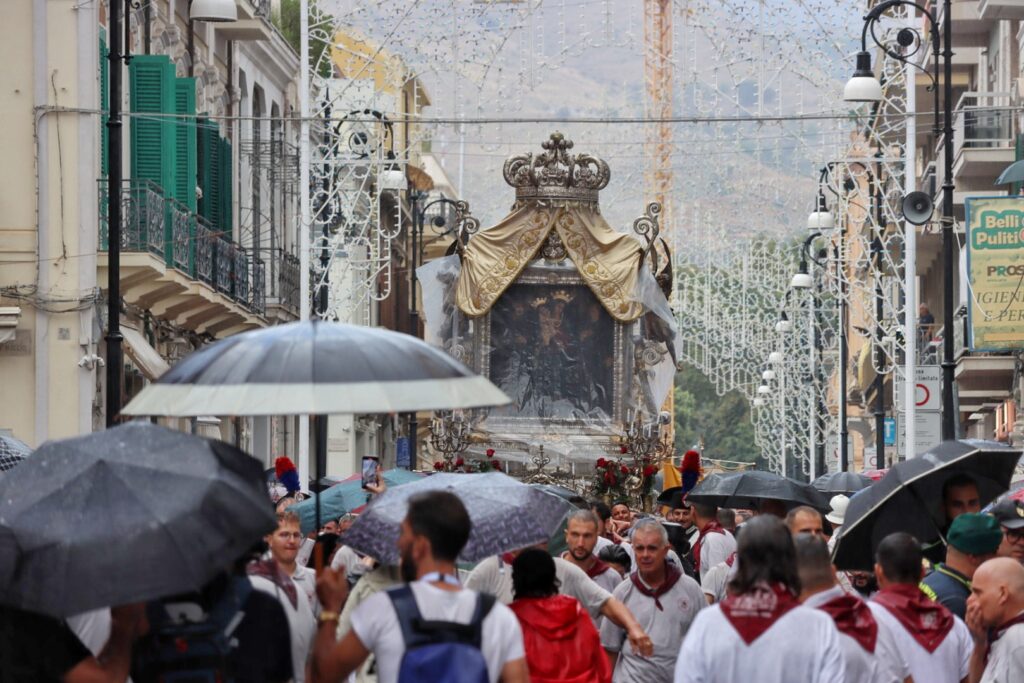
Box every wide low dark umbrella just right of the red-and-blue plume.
[686,470,828,510]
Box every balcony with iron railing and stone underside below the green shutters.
[97,180,266,337]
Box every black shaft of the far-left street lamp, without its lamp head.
[105,0,127,427]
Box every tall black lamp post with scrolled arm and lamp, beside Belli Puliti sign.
[843,0,957,441]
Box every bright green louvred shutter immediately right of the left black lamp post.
[128,54,176,195]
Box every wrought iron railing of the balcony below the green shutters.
[99,179,268,321]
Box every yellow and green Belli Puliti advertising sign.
[965,197,1024,351]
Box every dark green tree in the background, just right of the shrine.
[675,367,759,463]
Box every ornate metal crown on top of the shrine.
[503,132,611,204]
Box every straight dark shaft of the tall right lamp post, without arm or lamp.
[936,0,959,441]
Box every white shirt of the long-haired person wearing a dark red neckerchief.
[675,605,846,683]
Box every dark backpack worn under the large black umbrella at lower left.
[131,577,252,683]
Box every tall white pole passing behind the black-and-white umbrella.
[298,0,309,491]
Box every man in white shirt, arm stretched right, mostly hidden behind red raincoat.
[466,553,652,654]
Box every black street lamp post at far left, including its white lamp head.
[103,0,238,427]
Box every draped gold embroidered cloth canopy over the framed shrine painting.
[456,202,643,323]
